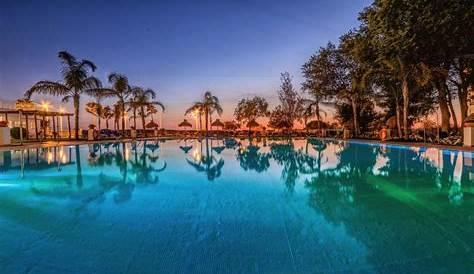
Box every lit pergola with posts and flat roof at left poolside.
[0,109,74,141]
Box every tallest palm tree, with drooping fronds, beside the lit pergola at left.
[25,51,101,139]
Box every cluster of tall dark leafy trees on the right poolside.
[302,0,474,138]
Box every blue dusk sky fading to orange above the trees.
[0,0,370,128]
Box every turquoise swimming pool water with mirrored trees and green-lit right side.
[0,139,474,273]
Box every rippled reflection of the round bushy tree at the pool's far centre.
[236,145,270,173]
